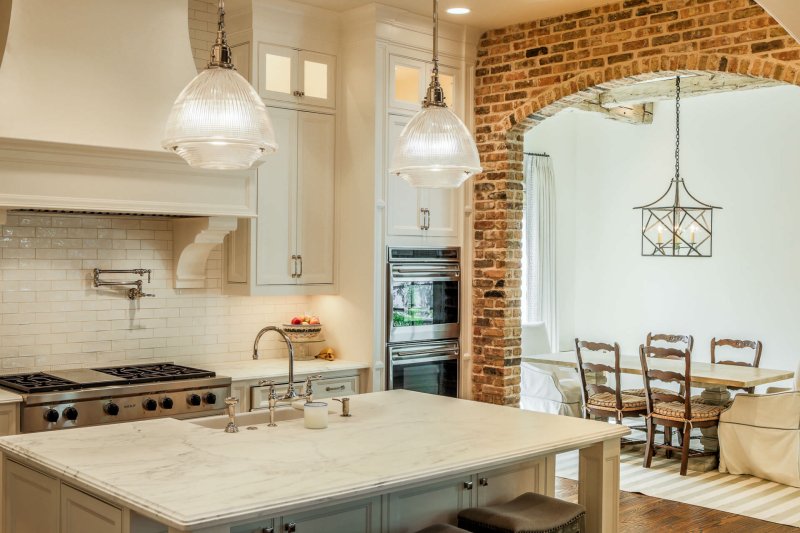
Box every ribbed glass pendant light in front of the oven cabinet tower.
[389,0,482,188]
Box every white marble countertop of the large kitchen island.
[0,390,628,530]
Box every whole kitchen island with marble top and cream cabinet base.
[0,390,628,533]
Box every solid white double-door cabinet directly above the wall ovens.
[386,115,461,239]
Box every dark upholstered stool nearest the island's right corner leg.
[458,492,586,533]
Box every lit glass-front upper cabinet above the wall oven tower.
[388,54,462,116]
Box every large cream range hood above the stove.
[0,0,256,217]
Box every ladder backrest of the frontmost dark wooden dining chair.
[639,344,692,420]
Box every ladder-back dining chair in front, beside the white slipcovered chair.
[639,345,722,476]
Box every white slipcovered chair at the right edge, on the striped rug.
[718,390,800,487]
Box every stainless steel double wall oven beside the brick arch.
[386,248,461,397]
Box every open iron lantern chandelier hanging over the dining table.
[634,76,722,257]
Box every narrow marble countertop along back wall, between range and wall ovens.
[202,359,369,381]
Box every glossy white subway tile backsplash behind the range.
[0,213,309,372]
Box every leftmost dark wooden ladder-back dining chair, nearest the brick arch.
[575,339,647,444]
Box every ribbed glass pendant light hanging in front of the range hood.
[161,0,278,170]
